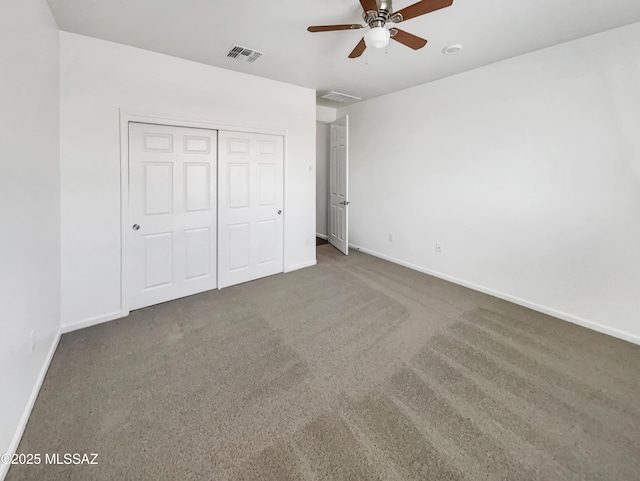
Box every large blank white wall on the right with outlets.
[338,24,640,342]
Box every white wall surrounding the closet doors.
[60,32,316,329]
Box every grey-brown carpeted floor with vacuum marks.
[7,245,640,481]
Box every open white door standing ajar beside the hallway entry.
[328,115,349,255]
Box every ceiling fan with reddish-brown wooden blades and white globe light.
[307,0,453,58]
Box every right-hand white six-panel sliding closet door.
[218,131,284,288]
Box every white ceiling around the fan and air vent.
[49,0,640,106]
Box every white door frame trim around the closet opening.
[121,109,288,319]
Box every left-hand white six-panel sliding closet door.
[129,123,217,309]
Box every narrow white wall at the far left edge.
[0,0,60,479]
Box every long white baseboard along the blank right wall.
[349,244,640,345]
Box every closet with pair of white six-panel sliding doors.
[128,122,284,309]
